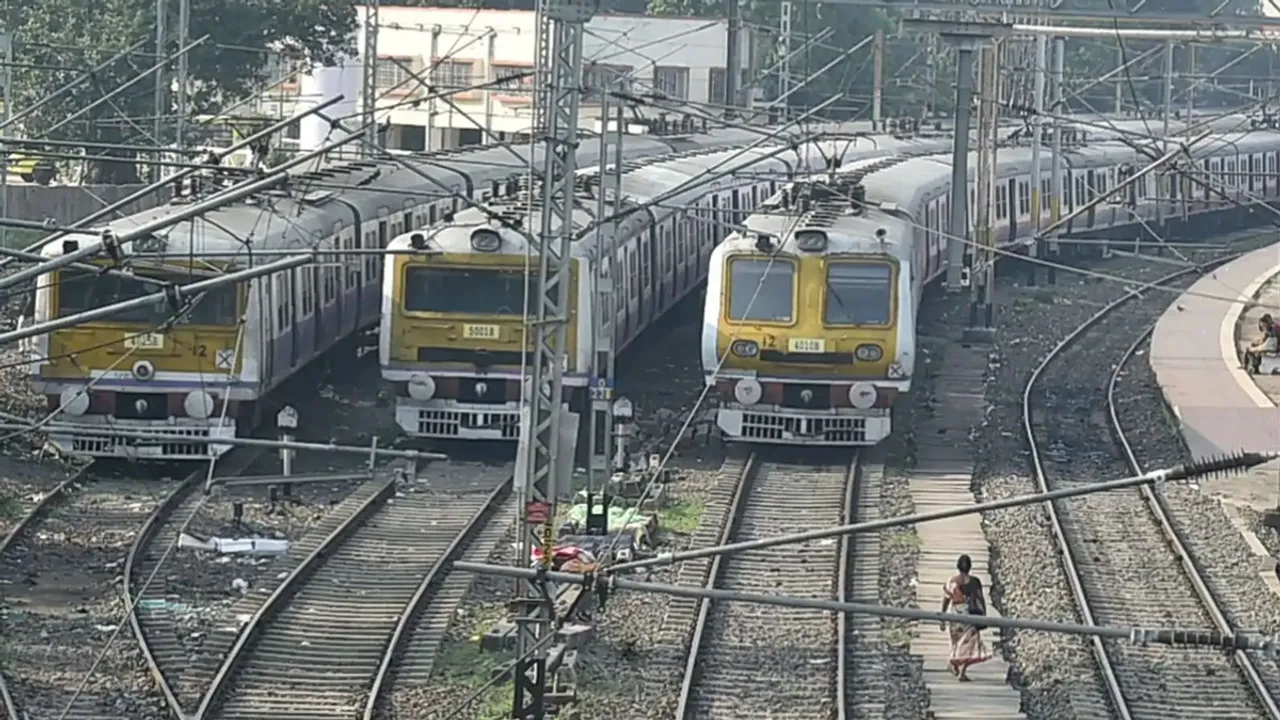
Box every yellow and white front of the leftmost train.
[27,234,247,460]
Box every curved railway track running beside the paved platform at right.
[1023,256,1280,720]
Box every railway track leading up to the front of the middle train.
[196,464,512,720]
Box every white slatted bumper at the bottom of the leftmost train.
[45,415,236,460]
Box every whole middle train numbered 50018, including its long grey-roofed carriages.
[379,137,926,441]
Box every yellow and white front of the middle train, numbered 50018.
[379,207,589,442]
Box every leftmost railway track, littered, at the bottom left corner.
[0,465,180,720]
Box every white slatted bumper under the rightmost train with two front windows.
[716,405,893,446]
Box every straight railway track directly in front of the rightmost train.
[677,455,860,720]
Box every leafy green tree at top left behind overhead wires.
[9,0,356,182]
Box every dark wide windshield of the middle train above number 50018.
[404,265,538,315]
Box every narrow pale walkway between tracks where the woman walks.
[908,347,1025,720]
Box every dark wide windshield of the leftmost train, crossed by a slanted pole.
[55,270,239,327]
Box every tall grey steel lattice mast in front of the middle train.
[513,0,598,717]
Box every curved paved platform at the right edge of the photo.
[1149,239,1280,457]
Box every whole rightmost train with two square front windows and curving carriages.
[701,124,1280,446]
